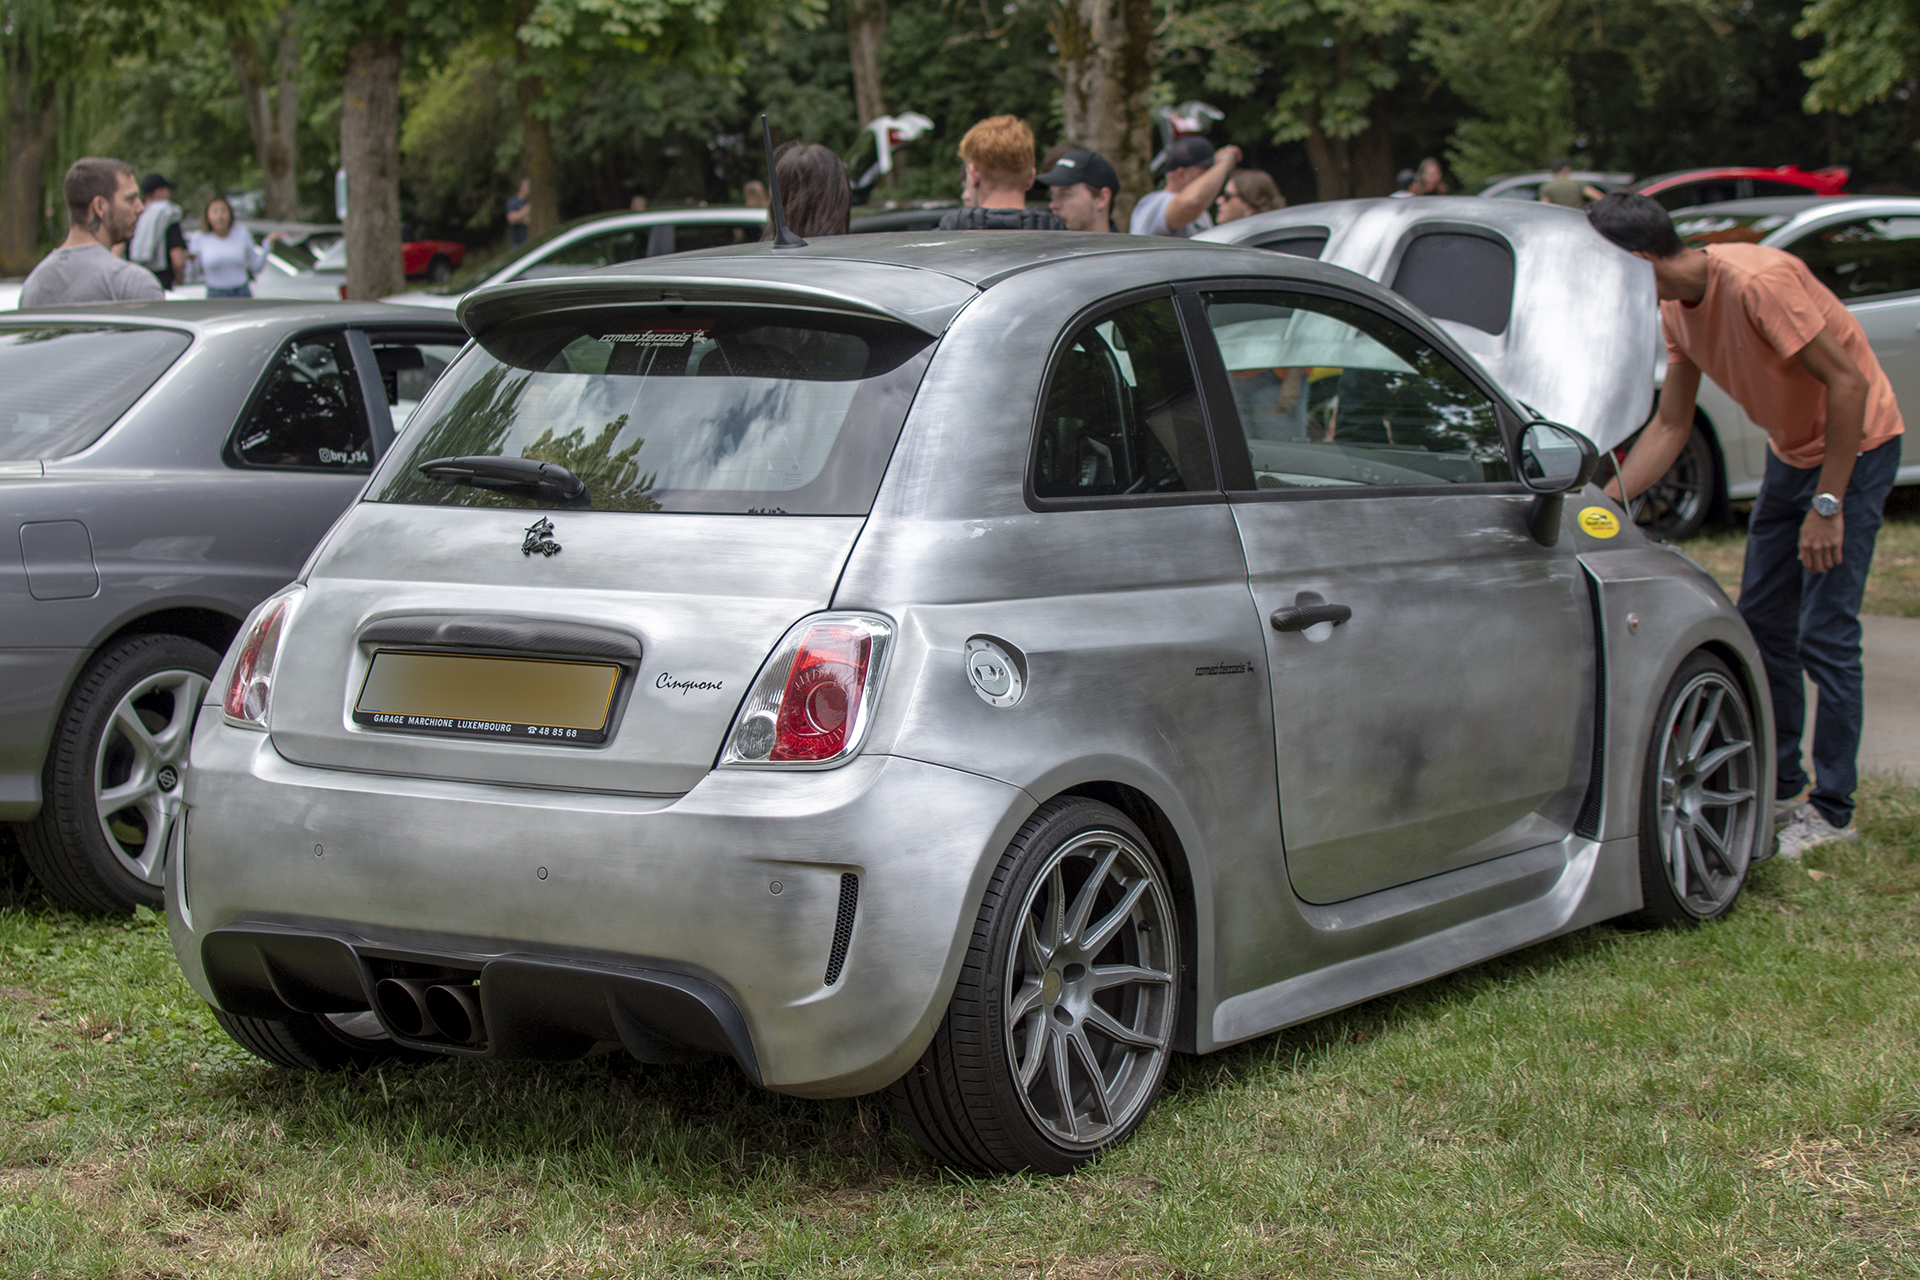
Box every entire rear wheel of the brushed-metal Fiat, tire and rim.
[889,796,1181,1173]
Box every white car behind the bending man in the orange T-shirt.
[1640,196,1920,539]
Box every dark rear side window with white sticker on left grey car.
[232,334,372,474]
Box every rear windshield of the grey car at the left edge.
[0,324,192,459]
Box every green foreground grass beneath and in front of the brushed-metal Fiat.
[0,781,1920,1278]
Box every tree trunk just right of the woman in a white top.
[340,35,407,297]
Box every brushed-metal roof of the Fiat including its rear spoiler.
[459,230,1320,334]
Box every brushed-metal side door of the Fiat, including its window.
[1183,284,1596,902]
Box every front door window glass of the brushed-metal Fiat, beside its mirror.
[1206,294,1513,489]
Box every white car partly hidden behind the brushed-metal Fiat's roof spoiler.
[385,209,766,311]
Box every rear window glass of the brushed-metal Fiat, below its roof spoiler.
[371,303,933,516]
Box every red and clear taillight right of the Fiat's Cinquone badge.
[720,614,893,768]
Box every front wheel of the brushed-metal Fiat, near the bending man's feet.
[1630,651,1772,929]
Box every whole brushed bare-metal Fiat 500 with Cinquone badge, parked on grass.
[167,221,1772,1171]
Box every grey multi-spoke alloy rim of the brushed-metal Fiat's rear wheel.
[1002,831,1175,1150]
